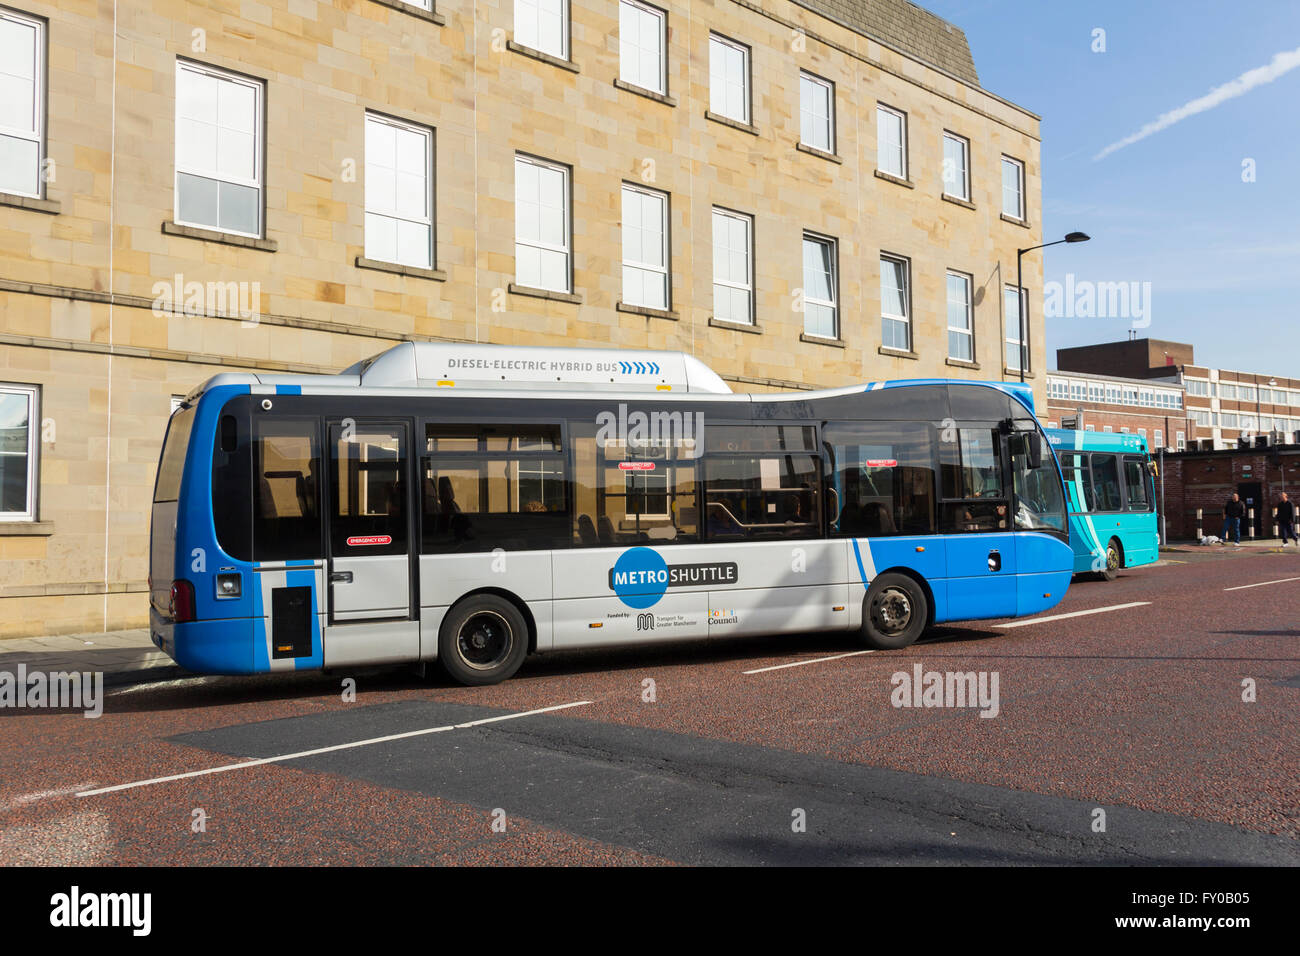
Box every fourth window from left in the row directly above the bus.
[515,156,572,293]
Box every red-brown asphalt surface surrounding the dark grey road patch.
[0,554,1300,865]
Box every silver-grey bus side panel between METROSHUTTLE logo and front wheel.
[709,538,849,637]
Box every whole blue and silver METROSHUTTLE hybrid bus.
[150,343,1074,684]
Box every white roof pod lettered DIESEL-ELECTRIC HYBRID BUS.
[343,342,731,394]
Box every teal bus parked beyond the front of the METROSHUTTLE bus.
[1044,428,1160,581]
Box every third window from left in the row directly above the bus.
[365,113,433,269]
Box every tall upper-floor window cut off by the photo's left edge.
[0,9,46,199]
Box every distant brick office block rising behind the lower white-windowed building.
[1048,338,1300,449]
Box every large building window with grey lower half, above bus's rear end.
[176,61,265,237]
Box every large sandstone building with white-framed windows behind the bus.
[0,0,1045,636]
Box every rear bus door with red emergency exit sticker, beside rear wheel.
[324,419,420,666]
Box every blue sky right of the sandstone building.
[919,0,1300,377]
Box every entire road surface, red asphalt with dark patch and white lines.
[0,548,1300,866]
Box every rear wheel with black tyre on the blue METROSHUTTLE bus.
[438,594,528,685]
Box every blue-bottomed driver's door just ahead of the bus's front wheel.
[940,423,1017,620]
